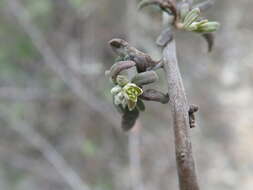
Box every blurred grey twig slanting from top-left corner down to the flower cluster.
[7,0,118,127]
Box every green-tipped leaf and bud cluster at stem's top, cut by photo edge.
[139,0,220,52]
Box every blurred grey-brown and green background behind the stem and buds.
[0,0,253,190]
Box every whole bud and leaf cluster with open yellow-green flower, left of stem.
[106,39,169,130]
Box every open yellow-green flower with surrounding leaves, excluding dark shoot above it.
[105,53,169,131]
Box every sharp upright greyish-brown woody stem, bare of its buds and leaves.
[163,39,199,190]
